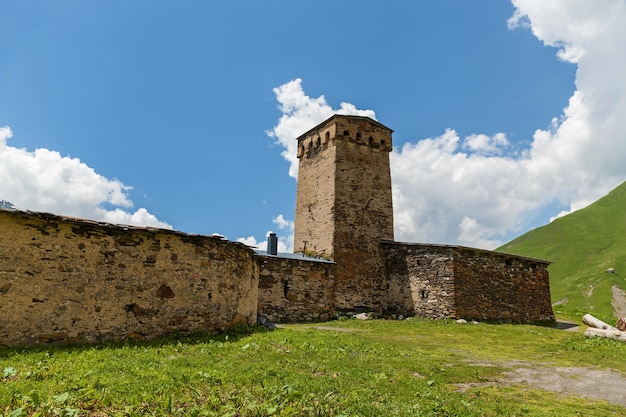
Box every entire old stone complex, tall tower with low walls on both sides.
[0,115,554,346]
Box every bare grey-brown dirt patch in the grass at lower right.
[458,362,626,407]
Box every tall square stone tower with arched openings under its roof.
[294,115,393,311]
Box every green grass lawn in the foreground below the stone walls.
[0,320,626,416]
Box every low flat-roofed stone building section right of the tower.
[383,242,554,323]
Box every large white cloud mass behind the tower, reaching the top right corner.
[269,0,626,249]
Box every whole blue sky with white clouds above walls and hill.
[0,0,626,250]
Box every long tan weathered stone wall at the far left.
[0,210,259,346]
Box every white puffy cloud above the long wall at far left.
[0,126,171,228]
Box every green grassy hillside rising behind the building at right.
[497,183,626,317]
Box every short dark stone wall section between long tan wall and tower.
[259,255,335,323]
